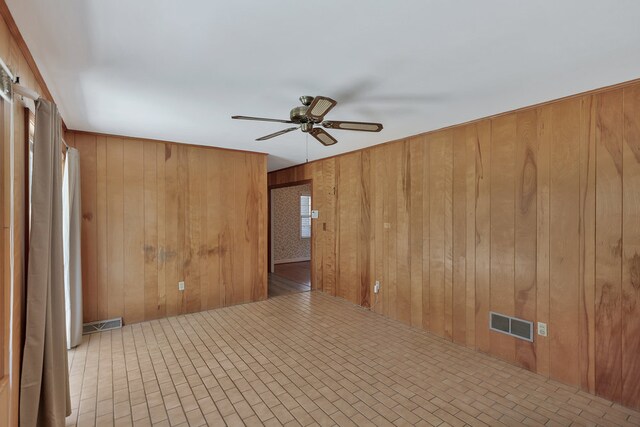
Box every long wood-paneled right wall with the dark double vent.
[269,78,640,408]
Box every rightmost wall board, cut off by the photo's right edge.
[622,85,640,407]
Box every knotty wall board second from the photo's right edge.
[595,90,623,400]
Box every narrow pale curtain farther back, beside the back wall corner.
[62,148,82,349]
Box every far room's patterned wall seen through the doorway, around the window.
[271,184,311,264]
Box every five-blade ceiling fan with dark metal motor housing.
[231,96,382,145]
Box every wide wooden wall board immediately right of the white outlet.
[549,99,581,385]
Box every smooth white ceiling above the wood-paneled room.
[7,0,640,170]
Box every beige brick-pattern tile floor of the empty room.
[67,292,640,426]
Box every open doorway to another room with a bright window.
[268,180,313,298]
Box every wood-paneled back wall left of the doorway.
[66,132,267,323]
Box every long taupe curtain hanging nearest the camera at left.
[20,99,71,427]
